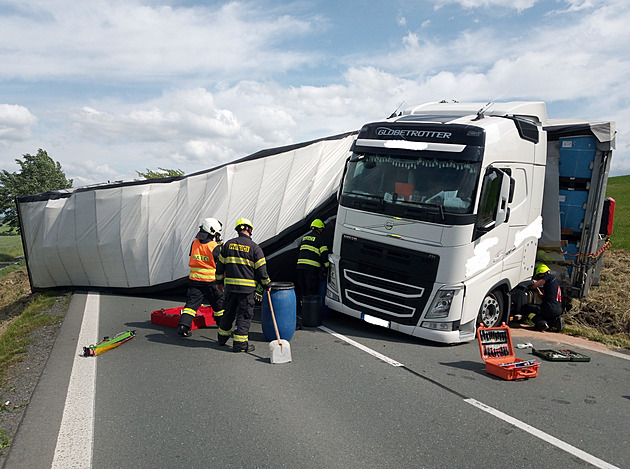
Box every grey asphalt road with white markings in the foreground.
[4,293,630,468]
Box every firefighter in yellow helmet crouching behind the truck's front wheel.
[523,264,564,332]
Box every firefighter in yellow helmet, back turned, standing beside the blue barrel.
[217,218,271,352]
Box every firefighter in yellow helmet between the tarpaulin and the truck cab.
[295,218,329,325]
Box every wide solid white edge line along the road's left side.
[52,292,100,469]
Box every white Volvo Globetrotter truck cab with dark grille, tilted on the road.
[326,102,612,343]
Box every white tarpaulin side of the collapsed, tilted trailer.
[17,133,356,290]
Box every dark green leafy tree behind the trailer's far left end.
[0,148,72,231]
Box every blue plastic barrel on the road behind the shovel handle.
[260,282,296,342]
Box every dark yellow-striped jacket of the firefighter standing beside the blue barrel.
[216,233,270,293]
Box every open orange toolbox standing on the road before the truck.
[477,323,540,380]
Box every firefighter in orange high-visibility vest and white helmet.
[177,218,224,337]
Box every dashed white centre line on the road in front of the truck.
[319,326,619,469]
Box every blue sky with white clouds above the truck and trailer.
[0,0,630,187]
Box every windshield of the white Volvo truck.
[341,152,481,218]
